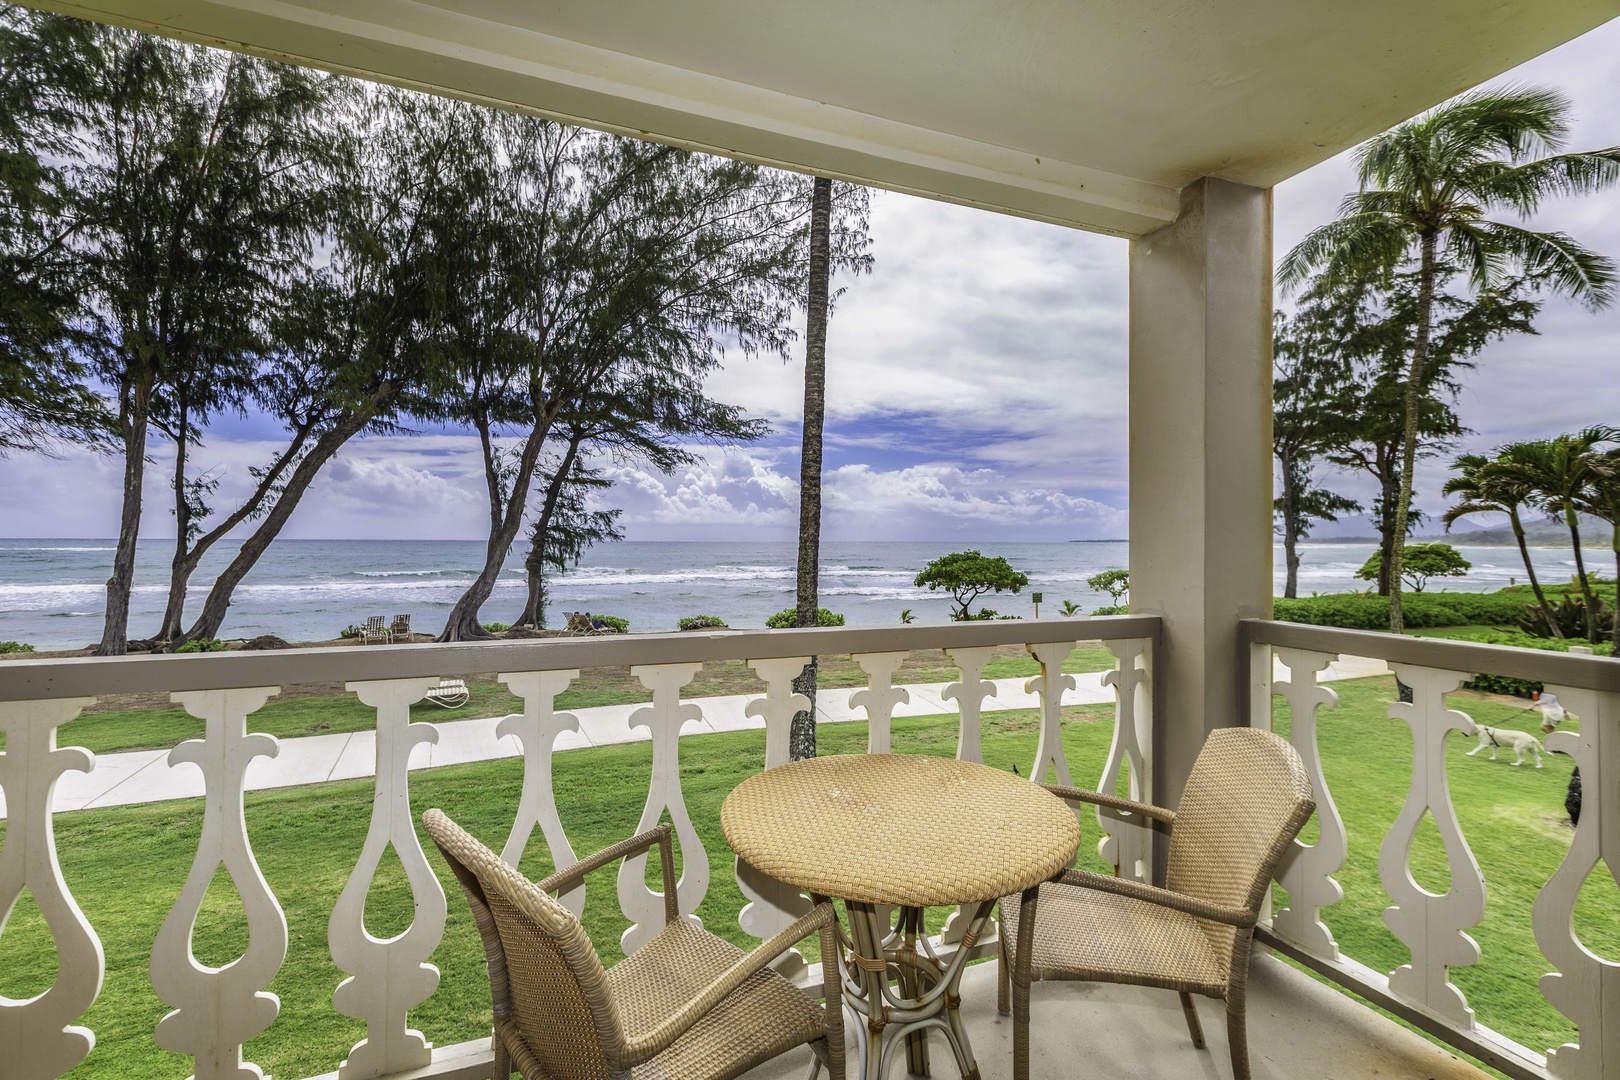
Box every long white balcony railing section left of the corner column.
[0,617,1160,1080]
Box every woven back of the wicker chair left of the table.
[423,810,624,1080]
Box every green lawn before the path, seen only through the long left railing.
[0,706,1113,1080]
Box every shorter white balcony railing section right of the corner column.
[1243,620,1620,1080]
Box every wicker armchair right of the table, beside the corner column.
[996,727,1315,1080]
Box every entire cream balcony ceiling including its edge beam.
[28,0,1620,235]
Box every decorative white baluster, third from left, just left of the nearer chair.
[327,678,446,1080]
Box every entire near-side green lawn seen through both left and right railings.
[0,678,1620,1078]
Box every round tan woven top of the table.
[719,755,1081,907]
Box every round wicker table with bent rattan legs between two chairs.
[719,755,1081,1080]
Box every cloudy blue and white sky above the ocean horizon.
[0,19,1620,542]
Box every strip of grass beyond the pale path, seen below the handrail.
[22,646,1115,753]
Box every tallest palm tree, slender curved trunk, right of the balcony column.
[1280,89,1620,633]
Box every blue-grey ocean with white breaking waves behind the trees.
[0,539,1612,649]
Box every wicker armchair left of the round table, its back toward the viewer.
[423,810,844,1080]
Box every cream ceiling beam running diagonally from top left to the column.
[37,0,1179,236]
